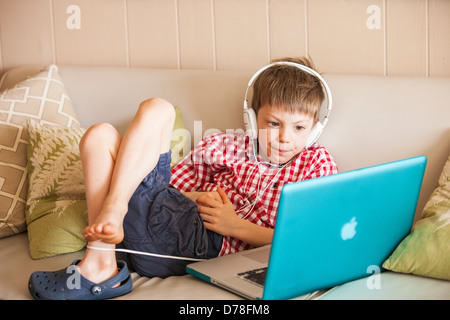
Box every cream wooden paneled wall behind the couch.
[0,0,450,77]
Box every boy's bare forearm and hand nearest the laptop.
[197,188,273,247]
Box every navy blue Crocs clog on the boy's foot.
[28,260,133,300]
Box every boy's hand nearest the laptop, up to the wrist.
[196,188,242,236]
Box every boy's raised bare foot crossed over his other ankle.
[83,208,123,244]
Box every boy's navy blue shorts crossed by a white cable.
[118,151,223,278]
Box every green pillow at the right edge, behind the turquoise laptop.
[383,157,450,280]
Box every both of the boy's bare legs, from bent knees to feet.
[78,98,175,283]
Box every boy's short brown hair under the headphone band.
[252,57,325,121]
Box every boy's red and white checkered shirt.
[171,133,338,255]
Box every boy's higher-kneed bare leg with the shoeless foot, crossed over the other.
[84,98,175,244]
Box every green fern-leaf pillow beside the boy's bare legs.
[25,120,87,259]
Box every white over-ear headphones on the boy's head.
[244,61,332,148]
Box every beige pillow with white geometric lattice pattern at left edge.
[0,65,79,238]
